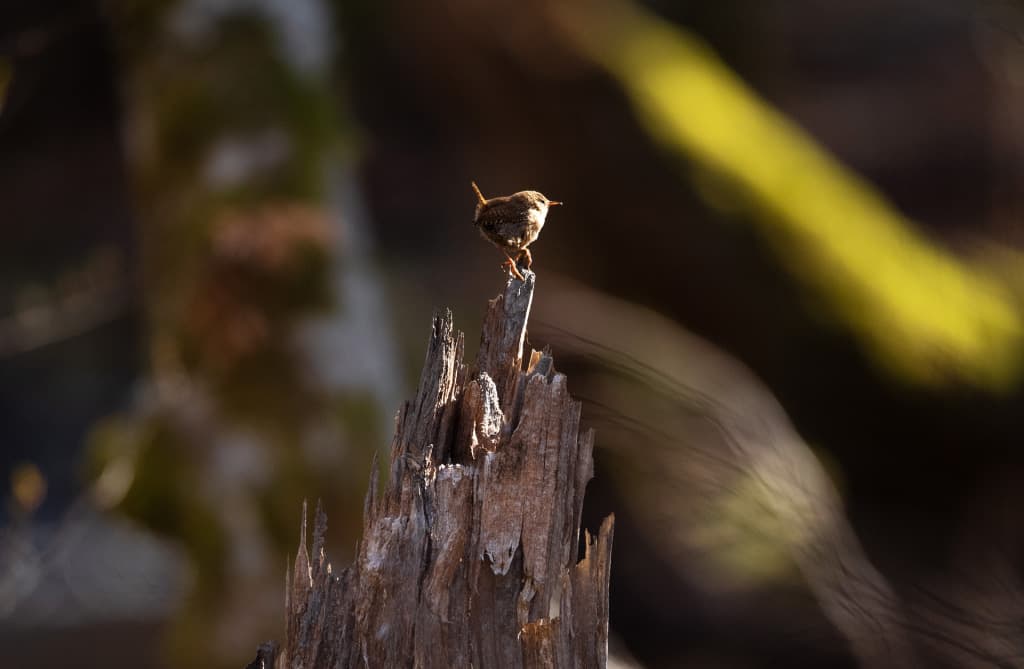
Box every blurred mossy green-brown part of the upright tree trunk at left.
[82,0,382,667]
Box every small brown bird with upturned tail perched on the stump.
[470,181,562,281]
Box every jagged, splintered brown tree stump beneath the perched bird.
[268,271,613,669]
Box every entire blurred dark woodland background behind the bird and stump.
[6,0,1024,668]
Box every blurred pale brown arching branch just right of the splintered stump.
[537,289,918,667]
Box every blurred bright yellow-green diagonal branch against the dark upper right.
[571,8,1024,389]
